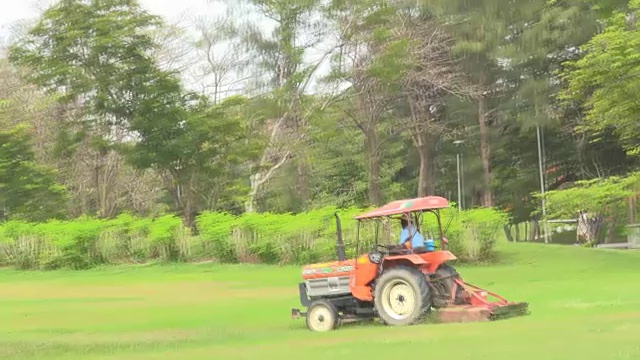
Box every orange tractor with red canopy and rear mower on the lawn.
[291,196,528,331]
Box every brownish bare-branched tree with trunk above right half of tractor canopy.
[389,6,476,196]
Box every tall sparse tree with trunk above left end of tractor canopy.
[326,0,408,205]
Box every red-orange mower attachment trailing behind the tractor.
[438,278,529,323]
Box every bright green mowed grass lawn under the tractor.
[0,240,640,360]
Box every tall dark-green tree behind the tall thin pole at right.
[493,0,597,225]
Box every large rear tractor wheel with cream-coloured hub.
[374,266,431,326]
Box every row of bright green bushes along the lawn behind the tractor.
[0,208,507,269]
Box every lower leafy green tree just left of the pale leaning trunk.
[125,88,262,227]
